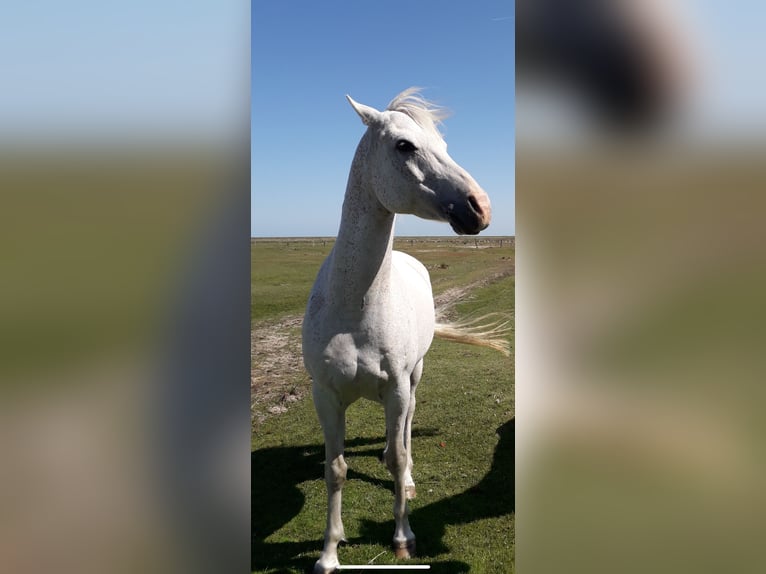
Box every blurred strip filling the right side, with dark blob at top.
[516,0,766,574]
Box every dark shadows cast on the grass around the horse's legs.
[250,420,514,574]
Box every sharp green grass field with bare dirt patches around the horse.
[251,237,515,574]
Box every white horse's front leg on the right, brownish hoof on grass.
[385,381,415,558]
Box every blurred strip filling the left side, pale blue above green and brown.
[0,0,250,573]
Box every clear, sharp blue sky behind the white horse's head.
[251,0,515,236]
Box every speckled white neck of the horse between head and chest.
[330,135,395,310]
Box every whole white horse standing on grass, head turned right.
[303,88,507,574]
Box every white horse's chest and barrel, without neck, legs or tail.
[304,251,435,407]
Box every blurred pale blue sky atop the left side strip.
[0,0,250,143]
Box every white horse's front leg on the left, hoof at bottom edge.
[314,384,348,574]
